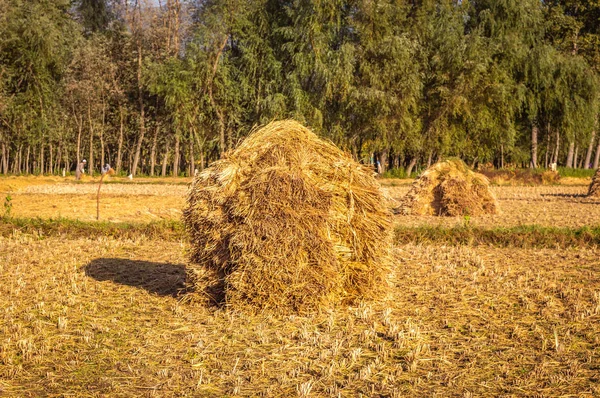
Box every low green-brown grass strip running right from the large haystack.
[394,225,600,249]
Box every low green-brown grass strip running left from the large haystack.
[0,217,185,240]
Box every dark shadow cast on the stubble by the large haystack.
[84,258,185,297]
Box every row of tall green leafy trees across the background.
[0,0,600,176]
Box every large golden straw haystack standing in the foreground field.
[184,120,391,312]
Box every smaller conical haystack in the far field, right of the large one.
[398,159,498,216]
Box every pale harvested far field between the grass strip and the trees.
[0,178,600,227]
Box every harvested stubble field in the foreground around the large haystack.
[0,234,600,397]
